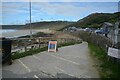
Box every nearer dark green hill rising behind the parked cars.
[62,12,120,28]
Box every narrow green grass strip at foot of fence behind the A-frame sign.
[12,41,81,60]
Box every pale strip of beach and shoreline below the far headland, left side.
[2,29,54,38]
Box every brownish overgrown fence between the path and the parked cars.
[73,31,114,52]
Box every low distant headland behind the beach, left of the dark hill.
[2,21,74,30]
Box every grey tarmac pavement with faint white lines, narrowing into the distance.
[2,42,99,78]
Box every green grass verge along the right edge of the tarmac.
[88,43,120,80]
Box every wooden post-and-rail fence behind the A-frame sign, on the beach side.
[12,37,81,53]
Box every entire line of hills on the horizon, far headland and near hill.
[2,12,120,30]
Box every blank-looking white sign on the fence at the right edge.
[108,47,120,59]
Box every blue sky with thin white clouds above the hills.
[0,0,118,25]
